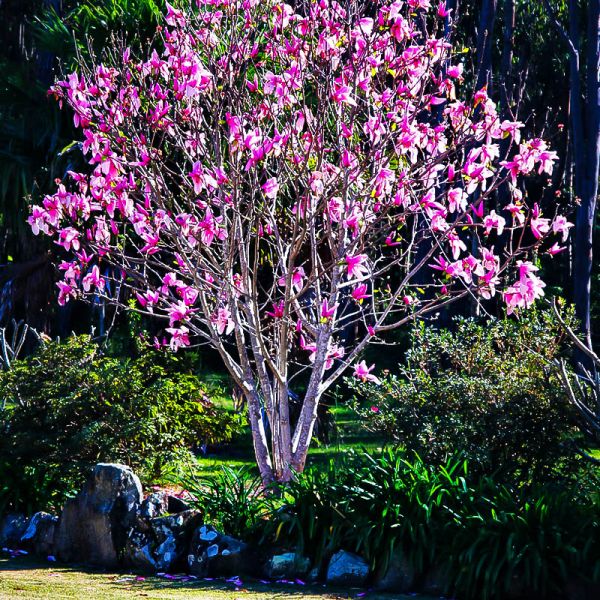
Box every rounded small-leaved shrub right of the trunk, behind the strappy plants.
[350,311,577,481]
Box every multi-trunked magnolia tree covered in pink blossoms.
[29,0,570,482]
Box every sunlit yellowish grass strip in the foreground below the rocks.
[0,557,433,600]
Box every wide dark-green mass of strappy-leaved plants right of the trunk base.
[268,449,600,599]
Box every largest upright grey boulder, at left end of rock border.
[56,463,142,567]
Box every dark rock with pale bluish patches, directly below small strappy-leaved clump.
[187,525,255,577]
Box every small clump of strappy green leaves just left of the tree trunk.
[178,466,268,540]
